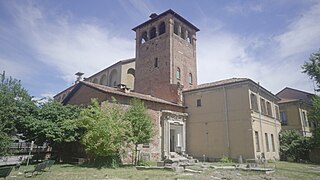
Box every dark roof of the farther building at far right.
[276,87,315,104]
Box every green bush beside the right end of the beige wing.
[280,130,311,161]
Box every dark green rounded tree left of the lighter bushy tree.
[20,99,81,158]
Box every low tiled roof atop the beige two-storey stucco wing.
[183,78,280,100]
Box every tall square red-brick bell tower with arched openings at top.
[132,9,199,104]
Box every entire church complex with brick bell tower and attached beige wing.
[54,9,281,161]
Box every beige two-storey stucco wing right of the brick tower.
[183,78,281,160]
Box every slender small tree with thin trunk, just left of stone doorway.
[125,99,154,164]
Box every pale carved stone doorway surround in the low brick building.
[161,110,188,159]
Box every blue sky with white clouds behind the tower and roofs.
[0,0,320,98]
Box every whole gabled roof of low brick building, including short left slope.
[63,81,183,107]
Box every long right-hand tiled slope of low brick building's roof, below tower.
[79,81,183,107]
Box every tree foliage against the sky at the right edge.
[302,50,320,91]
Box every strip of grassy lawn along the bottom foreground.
[7,161,320,180]
